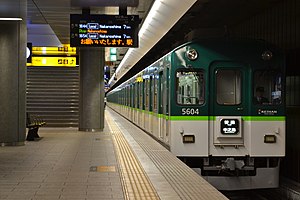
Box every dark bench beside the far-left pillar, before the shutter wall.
[26,113,46,141]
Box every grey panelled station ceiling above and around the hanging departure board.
[27,0,153,60]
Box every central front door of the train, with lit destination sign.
[209,62,250,148]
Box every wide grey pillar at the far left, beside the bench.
[0,0,27,146]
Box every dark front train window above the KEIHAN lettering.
[253,70,282,105]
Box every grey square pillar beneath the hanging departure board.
[79,48,105,132]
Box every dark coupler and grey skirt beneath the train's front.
[179,156,281,190]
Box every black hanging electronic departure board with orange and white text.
[70,14,139,48]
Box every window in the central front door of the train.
[216,69,242,105]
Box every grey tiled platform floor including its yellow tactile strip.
[0,109,227,200]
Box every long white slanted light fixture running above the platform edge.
[109,0,197,88]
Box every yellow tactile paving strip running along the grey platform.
[106,113,160,200]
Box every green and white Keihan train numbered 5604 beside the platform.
[106,38,286,190]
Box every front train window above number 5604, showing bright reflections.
[176,69,205,105]
